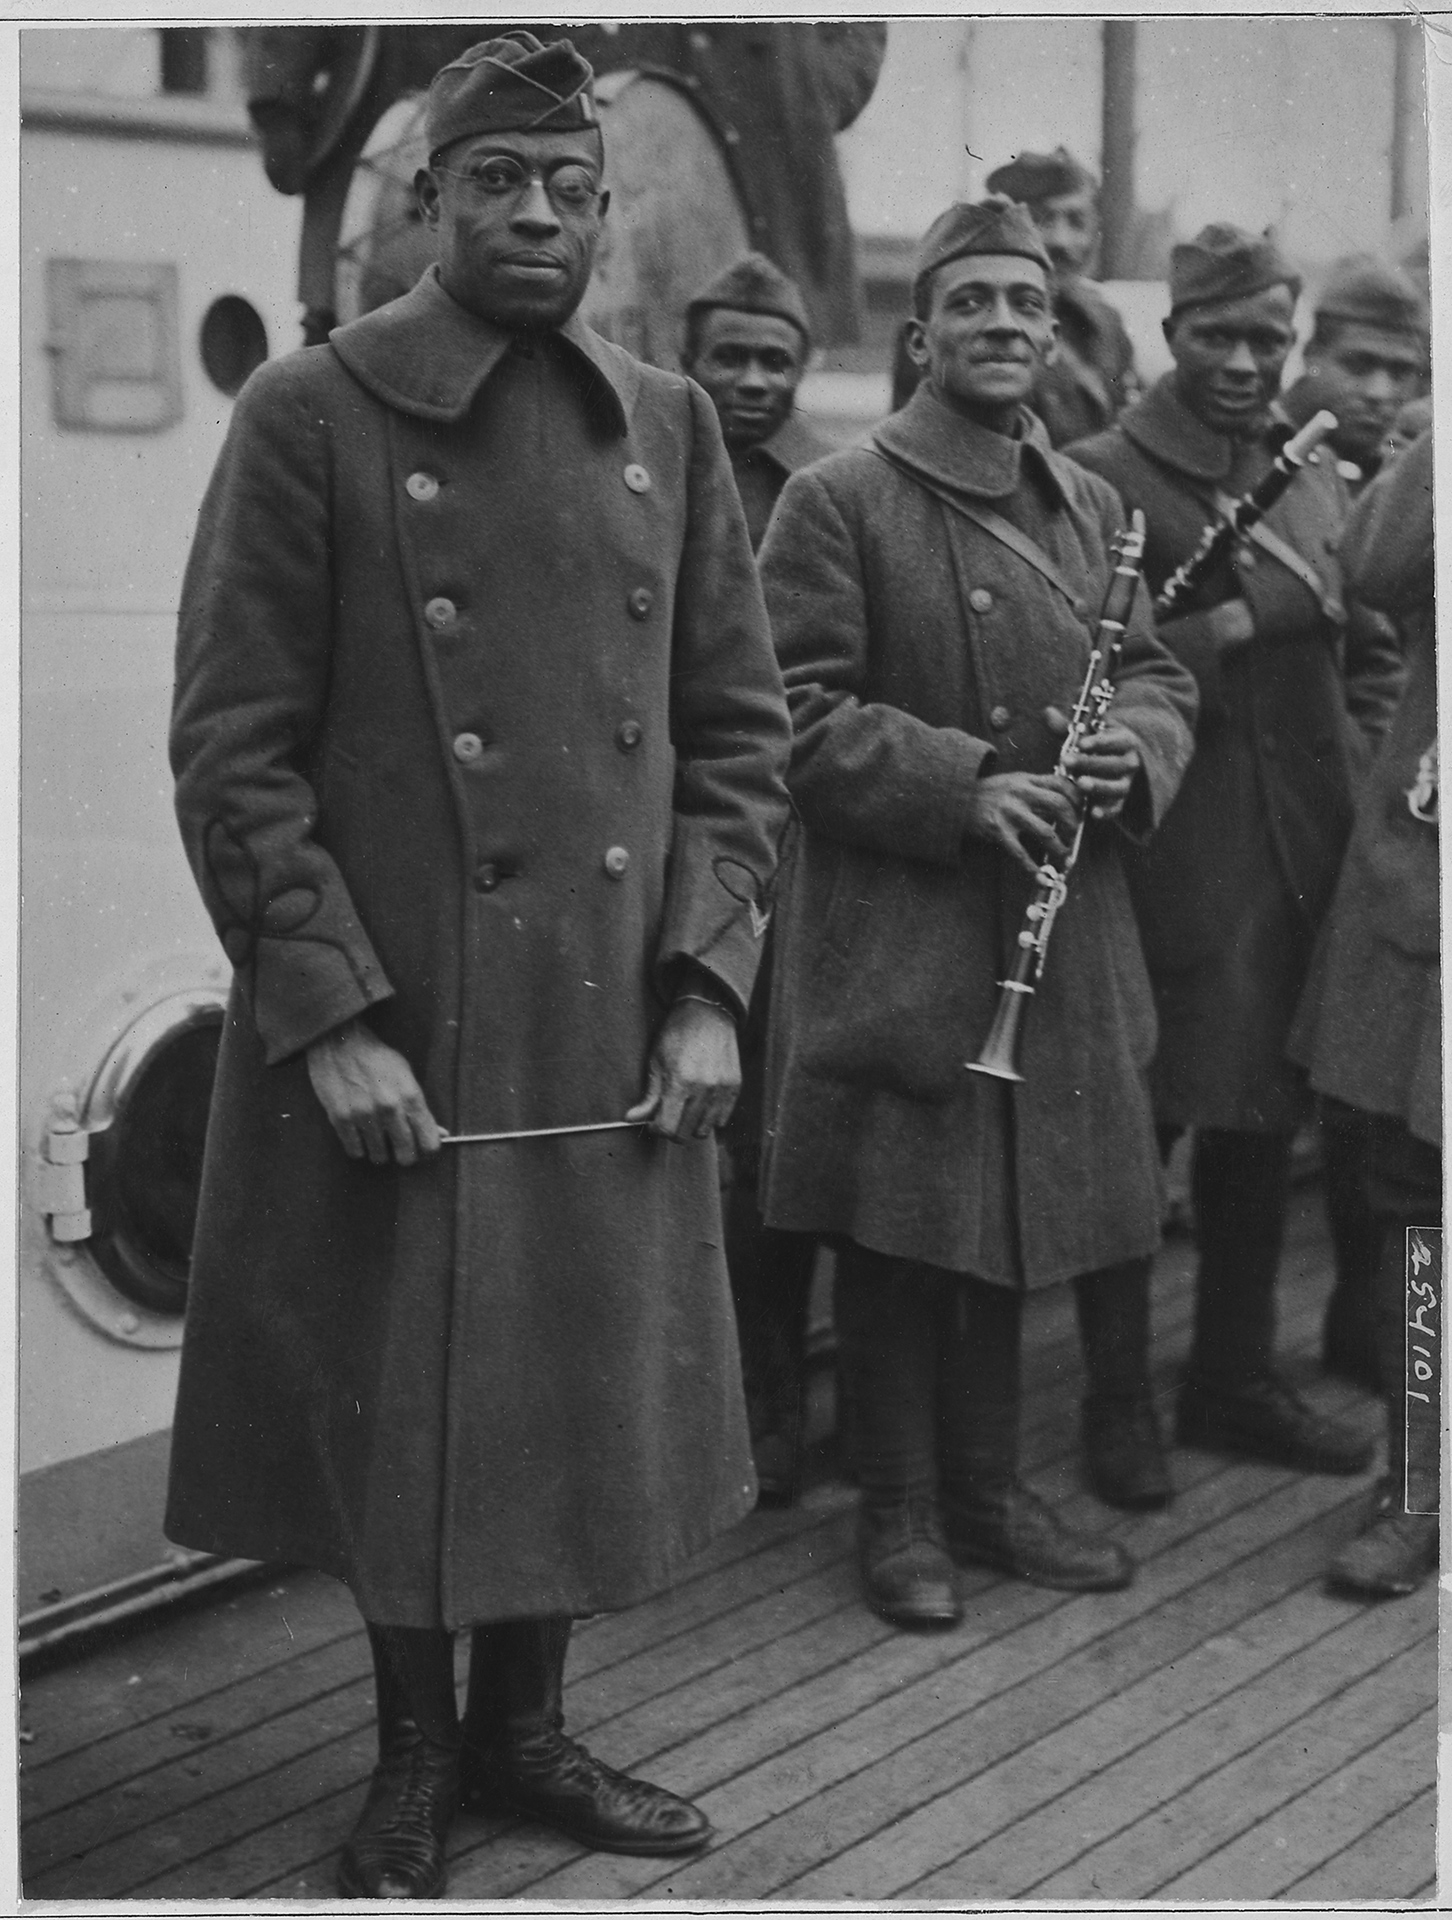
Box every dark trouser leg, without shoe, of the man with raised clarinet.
[1160,1127,1291,1390]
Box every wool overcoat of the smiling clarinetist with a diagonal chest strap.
[761,386,1195,1286]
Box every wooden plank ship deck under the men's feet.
[21,1190,1437,1907]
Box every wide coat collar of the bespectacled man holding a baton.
[338,267,640,434]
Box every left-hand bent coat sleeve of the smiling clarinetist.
[761,470,993,866]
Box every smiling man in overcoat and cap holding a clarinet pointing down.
[762,200,1195,1624]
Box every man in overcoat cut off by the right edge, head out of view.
[1291,430,1442,1599]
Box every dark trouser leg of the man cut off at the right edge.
[1364,1114,1442,1513]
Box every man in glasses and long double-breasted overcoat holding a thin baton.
[167,33,789,1897]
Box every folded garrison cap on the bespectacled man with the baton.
[424,29,599,161]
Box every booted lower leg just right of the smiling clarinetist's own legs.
[1074,1260,1174,1511]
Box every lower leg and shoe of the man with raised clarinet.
[1175,1129,1375,1473]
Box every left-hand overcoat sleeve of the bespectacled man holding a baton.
[171,363,392,1064]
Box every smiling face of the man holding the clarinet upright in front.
[907,253,1058,409]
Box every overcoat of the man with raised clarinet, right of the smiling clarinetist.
[1066,374,1400,1133]
